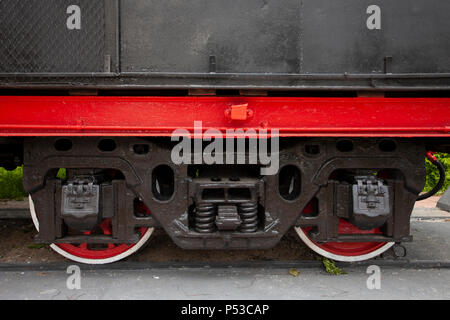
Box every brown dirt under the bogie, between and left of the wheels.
[0,219,316,263]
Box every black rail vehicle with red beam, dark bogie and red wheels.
[0,0,450,264]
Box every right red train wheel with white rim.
[295,219,395,262]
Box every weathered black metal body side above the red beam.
[0,0,450,90]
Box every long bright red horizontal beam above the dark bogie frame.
[0,96,450,137]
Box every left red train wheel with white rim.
[29,196,154,264]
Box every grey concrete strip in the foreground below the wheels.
[0,267,450,300]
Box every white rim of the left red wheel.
[28,196,155,264]
